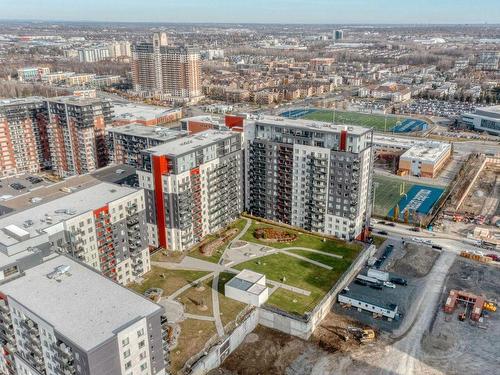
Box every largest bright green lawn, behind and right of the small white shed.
[234,251,351,315]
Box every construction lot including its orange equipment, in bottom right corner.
[422,257,500,374]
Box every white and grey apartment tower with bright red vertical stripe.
[137,130,243,251]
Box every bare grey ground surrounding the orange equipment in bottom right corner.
[422,258,500,374]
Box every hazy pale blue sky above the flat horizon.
[0,0,500,24]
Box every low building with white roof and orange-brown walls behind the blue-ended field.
[398,141,452,178]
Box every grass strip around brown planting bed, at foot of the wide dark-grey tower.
[241,220,362,259]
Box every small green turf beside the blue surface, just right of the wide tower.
[373,176,414,217]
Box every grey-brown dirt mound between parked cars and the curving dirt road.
[389,244,439,277]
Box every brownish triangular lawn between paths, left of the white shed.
[128,266,209,296]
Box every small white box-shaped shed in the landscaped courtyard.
[224,270,268,306]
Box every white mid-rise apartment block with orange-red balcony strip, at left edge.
[0,183,151,284]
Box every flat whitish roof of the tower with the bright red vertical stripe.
[148,129,238,156]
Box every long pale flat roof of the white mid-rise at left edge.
[0,182,137,246]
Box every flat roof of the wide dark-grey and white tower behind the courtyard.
[256,115,371,135]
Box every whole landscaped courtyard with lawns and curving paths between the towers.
[129,217,362,373]
